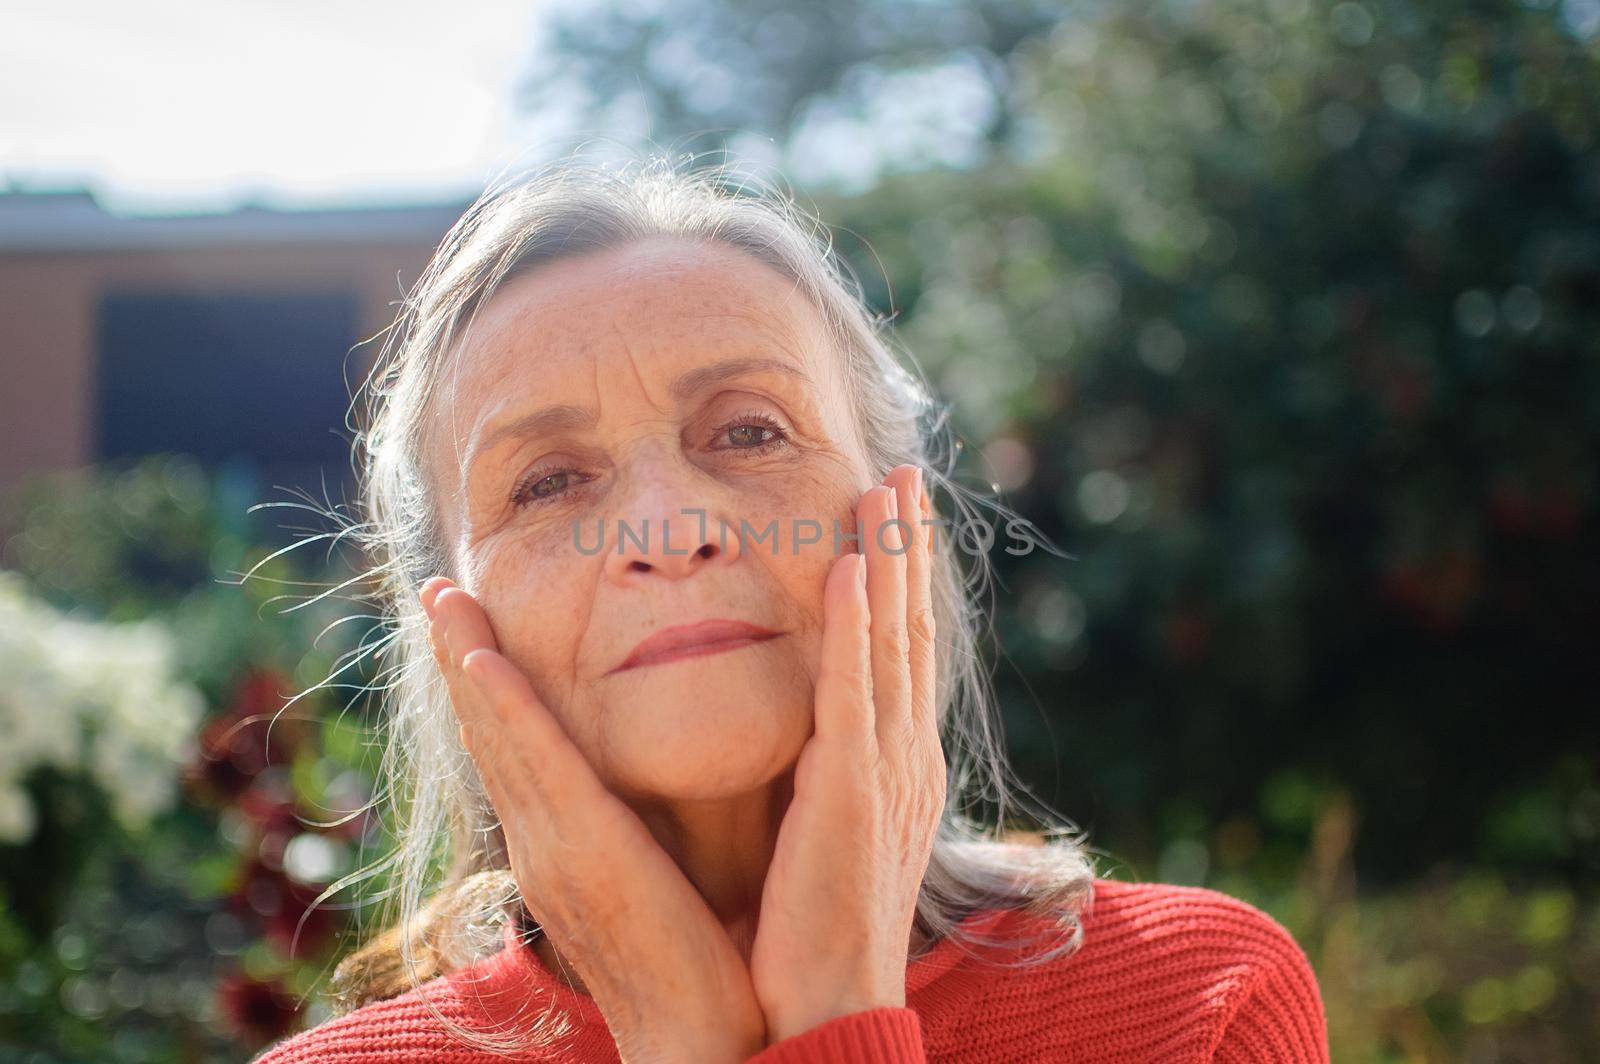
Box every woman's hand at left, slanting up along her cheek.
[421,576,766,1061]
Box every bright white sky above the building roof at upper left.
[0,0,563,210]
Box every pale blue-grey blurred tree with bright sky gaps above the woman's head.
[520,0,1062,181]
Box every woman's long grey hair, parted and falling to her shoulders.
[305,147,1094,1053]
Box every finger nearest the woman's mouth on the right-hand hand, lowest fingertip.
[816,554,874,744]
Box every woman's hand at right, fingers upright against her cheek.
[750,466,946,1042]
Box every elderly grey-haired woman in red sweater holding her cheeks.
[259,153,1326,1064]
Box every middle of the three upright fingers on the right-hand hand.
[862,485,910,750]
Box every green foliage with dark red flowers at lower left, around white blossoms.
[0,456,384,1061]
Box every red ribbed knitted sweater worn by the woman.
[256,880,1328,1064]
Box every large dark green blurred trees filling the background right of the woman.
[521,0,1600,880]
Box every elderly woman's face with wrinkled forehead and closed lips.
[427,238,872,798]
